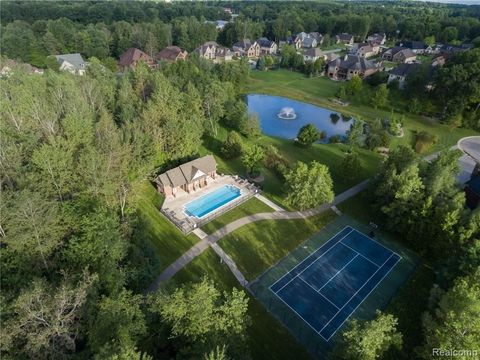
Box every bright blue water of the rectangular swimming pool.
[185,185,241,218]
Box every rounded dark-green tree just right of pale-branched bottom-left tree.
[89,289,147,351]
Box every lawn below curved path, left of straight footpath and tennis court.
[167,249,310,360]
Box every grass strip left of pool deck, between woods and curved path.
[132,180,198,271]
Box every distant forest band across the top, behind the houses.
[1,1,480,67]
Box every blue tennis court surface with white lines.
[270,226,401,341]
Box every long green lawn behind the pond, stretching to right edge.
[245,70,476,152]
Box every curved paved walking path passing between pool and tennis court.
[147,179,369,292]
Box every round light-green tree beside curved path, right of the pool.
[285,161,334,210]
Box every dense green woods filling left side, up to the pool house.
[0,59,253,359]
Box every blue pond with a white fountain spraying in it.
[247,94,353,142]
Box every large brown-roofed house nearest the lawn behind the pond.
[327,55,380,80]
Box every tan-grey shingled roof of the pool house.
[155,155,217,187]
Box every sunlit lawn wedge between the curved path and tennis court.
[219,210,336,281]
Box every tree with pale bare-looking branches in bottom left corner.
[2,274,96,359]
